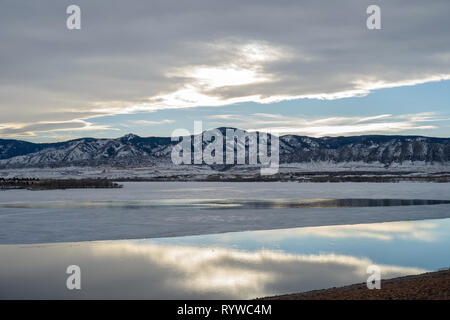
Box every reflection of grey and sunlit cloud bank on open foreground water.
[0,236,425,299]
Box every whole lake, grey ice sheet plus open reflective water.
[0,182,450,299]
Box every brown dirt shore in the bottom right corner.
[261,269,450,300]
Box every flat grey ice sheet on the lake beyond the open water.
[0,182,450,244]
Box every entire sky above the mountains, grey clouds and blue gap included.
[0,0,450,142]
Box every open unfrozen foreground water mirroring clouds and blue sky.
[0,219,450,299]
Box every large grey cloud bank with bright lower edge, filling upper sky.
[0,0,450,135]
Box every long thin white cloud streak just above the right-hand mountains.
[210,112,449,137]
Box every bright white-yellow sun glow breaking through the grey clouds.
[137,40,289,111]
